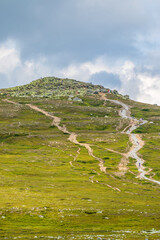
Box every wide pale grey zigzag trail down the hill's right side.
[101,94,160,185]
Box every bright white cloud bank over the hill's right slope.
[57,57,160,104]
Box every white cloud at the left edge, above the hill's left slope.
[0,40,51,87]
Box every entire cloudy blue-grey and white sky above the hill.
[0,0,160,105]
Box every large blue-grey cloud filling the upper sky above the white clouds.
[0,0,160,64]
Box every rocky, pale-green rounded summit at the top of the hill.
[0,77,127,98]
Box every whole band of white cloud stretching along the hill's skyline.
[0,40,160,104]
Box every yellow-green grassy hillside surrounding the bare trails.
[0,78,160,239]
